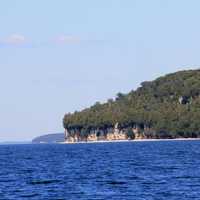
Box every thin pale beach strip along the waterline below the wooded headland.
[60,138,200,144]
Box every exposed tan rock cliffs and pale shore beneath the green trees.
[64,123,200,144]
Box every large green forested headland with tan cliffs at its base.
[63,70,200,142]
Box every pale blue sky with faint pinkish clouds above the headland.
[0,0,200,142]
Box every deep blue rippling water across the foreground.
[0,141,200,200]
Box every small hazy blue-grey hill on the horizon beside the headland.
[32,133,64,143]
